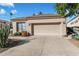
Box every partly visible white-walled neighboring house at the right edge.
[67,16,79,34]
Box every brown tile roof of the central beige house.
[12,14,64,21]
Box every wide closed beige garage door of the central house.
[33,23,61,35]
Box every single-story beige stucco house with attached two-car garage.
[12,14,66,35]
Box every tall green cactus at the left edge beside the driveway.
[0,25,10,48]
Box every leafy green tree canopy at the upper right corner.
[56,3,79,17]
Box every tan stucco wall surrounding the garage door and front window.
[12,18,66,35]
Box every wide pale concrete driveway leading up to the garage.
[0,36,79,56]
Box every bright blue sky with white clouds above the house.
[0,3,56,20]
